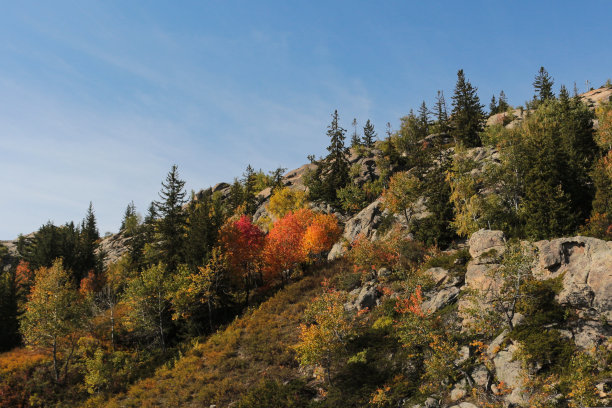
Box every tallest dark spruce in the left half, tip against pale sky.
[155,165,186,271]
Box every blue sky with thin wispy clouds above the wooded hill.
[0,0,612,239]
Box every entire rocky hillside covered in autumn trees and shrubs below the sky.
[0,77,612,408]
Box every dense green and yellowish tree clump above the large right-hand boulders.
[448,82,611,239]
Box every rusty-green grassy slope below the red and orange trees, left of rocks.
[94,264,342,407]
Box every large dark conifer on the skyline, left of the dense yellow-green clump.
[452,69,485,147]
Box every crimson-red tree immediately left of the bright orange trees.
[219,215,264,304]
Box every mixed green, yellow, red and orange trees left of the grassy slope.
[3,160,341,404]
